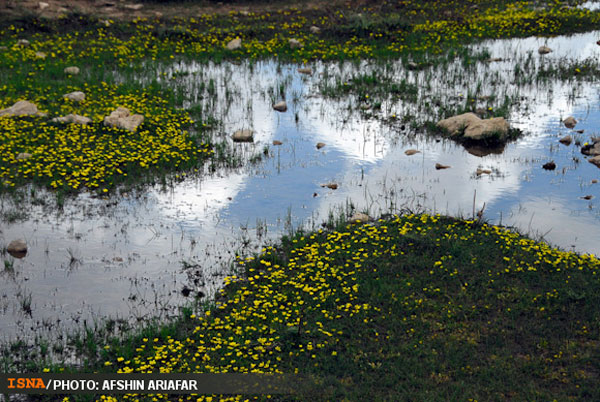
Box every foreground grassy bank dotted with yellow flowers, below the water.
[8,215,600,401]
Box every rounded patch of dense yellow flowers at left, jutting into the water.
[0,83,212,191]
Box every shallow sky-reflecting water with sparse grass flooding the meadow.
[0,32,600,338]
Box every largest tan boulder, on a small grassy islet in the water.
[437,113,510,141]
